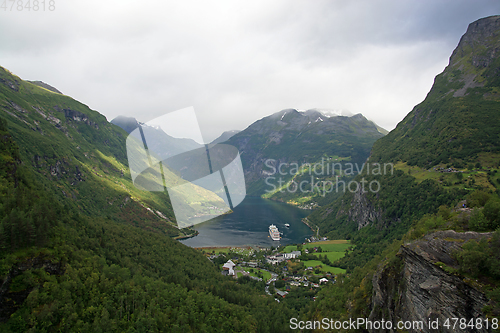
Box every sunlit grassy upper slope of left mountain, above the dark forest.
[0,68,198,236]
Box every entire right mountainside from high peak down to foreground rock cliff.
[308,16,500,326]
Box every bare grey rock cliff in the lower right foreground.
[369,230,491,332]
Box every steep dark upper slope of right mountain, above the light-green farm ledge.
[372,16,500,168]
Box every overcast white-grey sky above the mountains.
[0,0,500,141]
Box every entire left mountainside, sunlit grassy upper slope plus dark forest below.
[0,68,298,333]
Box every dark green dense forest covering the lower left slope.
[0,119,304,332]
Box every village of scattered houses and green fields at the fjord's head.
[197,240,352,302]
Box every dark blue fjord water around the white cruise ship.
[181,197,312,247]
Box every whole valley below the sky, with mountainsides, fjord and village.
[0,15,500,333]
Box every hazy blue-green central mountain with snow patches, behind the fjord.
[227,109,383,204]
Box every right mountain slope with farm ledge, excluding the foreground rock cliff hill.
[310,16,500,244]
